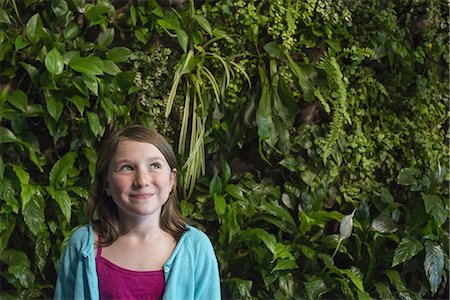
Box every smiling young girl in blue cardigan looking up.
[54,126,220,300]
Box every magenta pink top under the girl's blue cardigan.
[95,246,164,300]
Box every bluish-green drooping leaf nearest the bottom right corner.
[423,240,444,295]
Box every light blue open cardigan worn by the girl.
[54,225,221,300]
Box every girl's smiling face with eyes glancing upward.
[106,140,176,219]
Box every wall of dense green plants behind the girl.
[0,0,450,299]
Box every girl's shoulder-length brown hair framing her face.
[87,125,186,246]
